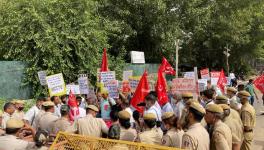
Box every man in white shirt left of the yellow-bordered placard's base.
[24,97,46,128]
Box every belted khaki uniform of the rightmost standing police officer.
[241,103,256,150]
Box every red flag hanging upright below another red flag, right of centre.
[155,65,169,106]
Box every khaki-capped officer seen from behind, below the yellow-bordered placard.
[39,101,59,133]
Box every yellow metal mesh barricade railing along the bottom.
[50,132,180,150]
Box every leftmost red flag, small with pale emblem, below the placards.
[68,90,80,121]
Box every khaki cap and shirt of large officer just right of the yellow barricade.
[181,103,210,150]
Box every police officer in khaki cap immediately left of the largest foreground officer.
[162,112,184,148]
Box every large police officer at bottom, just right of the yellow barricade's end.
[182,102,210,150]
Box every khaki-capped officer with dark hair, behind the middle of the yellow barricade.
[118,110,137,142]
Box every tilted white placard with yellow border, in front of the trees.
[46,73,66,96]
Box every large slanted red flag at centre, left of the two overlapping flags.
[131,71,149,113]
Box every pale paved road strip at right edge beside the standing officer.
[252,94,264,150]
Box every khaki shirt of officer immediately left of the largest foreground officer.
[162,128,184,148]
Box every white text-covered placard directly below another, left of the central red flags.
[104,80,119,98]
